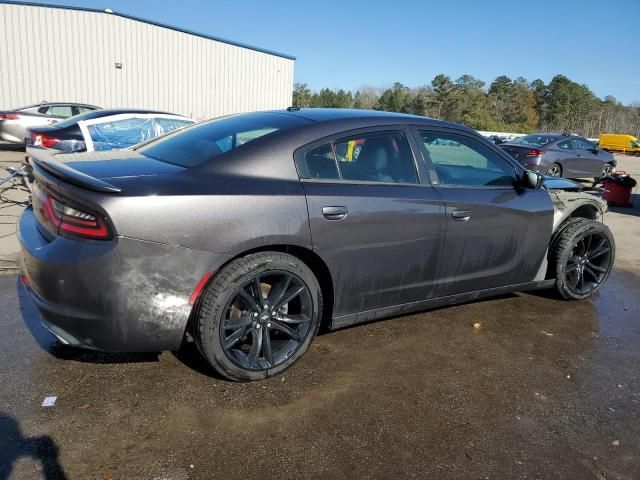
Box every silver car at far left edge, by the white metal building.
[0,103,100,143]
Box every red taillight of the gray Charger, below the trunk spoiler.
[33,183,112,240]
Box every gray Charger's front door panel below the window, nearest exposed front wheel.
[434,187,553,297]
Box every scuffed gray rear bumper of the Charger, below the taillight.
[18,208,229,352]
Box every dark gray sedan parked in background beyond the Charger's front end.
[500,133,616,179]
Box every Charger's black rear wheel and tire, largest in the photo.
[194,252,322,381]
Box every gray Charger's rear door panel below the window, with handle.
[303,182,445,316]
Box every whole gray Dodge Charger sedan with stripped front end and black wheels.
[19,108,615,381]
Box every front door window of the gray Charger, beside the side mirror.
[420,131,516,187]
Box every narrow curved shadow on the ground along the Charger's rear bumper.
[17,278,160,366]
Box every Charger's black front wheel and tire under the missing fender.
[551,218,615,300]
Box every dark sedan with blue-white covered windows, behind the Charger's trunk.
[26,108,195,152]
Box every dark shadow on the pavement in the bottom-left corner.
[0,412,67,480]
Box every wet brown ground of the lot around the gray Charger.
[0,147,640,479]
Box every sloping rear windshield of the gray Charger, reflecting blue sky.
[136,113,308,167]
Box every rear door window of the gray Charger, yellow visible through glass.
[305,132,418,183]
